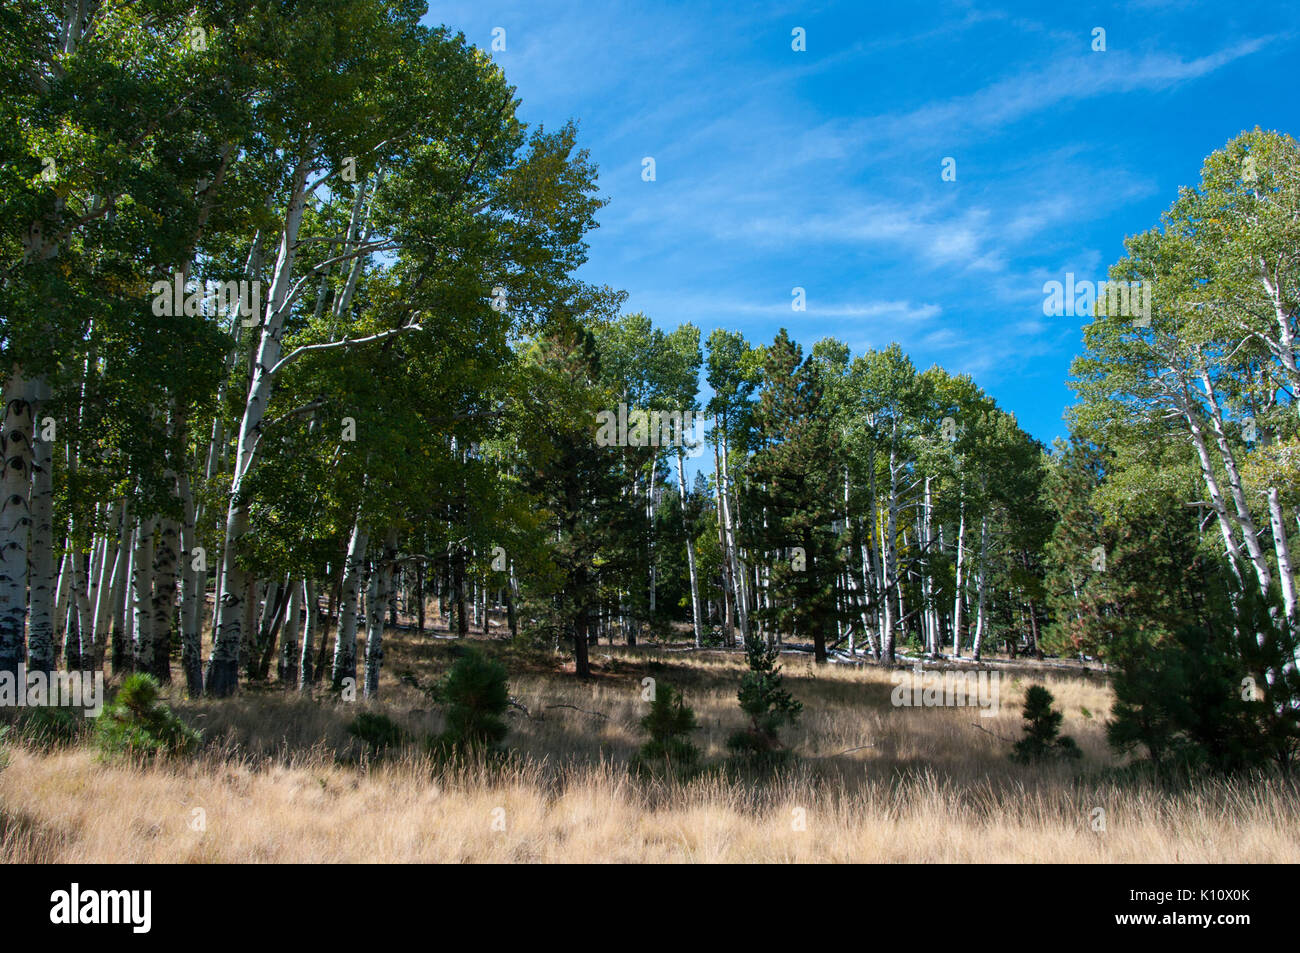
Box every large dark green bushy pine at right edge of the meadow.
[1106,564,1300,776]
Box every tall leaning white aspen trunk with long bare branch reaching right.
[205,147,313,696]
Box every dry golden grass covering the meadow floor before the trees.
[0,632,1300,863]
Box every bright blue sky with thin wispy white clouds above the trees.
[426,0,1300,442]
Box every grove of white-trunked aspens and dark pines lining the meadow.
[0,0,1300,780]
